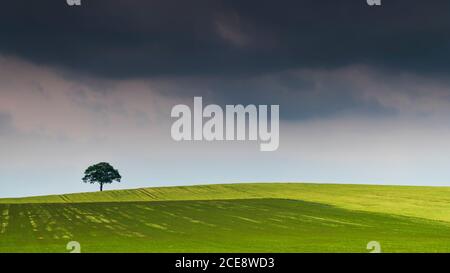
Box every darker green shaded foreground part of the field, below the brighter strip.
[0,199,450,253]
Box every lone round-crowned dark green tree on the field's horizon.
[83,162,122,191]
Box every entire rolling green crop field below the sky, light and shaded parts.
[0,183,450,252]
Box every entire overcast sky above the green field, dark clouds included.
[0,0,450,197]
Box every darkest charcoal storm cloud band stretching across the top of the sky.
[0,0,450,78]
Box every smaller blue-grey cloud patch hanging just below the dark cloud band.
[162,67,398,120]
